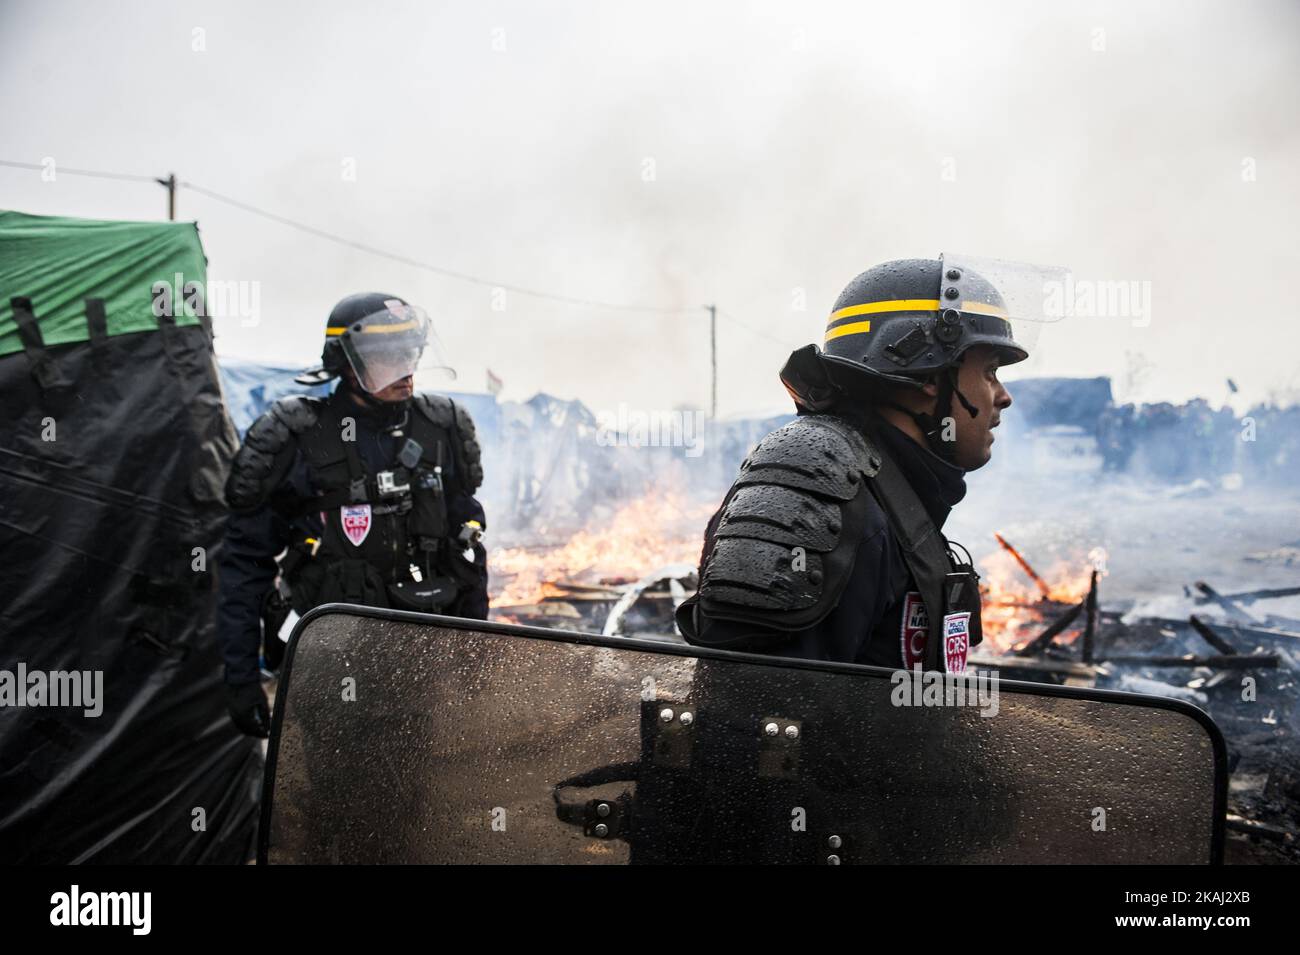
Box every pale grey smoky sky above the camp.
[0,0,1300,414]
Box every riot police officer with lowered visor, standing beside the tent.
[217,292,488,737]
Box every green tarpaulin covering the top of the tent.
[0,212,207,355]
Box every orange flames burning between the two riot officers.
[488,490,716,607]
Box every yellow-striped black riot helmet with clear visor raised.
[781,256,1045,456]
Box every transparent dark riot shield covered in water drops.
[259,613,1227,864]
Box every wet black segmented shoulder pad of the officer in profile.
[699,416,883,630]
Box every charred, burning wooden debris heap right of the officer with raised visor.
[971,535,1300,863]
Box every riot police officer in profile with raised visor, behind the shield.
[677,257,1028,672]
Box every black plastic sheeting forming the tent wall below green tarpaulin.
[0,323,263,863]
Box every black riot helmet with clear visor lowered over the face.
[296,292,430,394]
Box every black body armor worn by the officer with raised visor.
[677,414,980,669]
